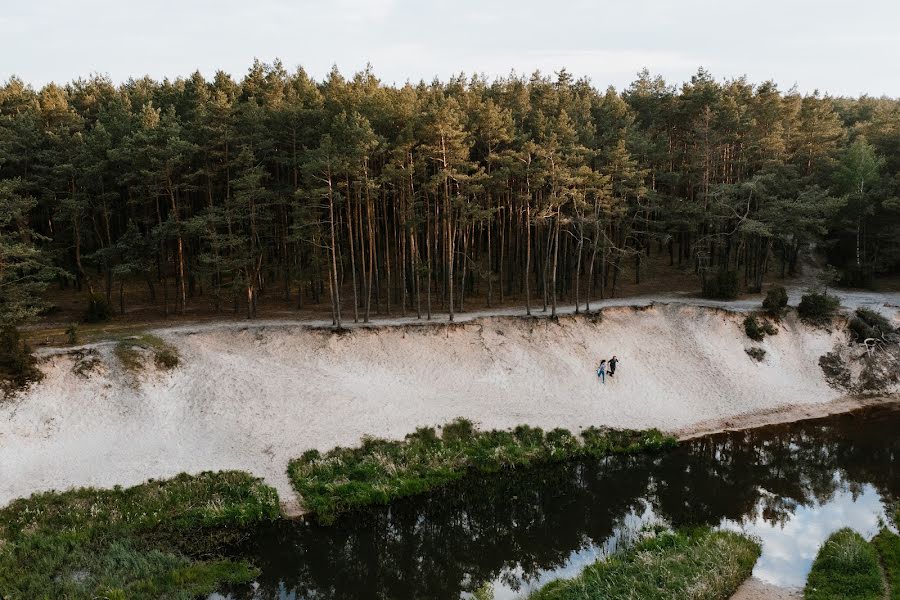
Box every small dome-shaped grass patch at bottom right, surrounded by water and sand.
[803,528,884,600]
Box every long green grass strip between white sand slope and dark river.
[288,419,676,523]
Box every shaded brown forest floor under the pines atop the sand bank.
[23,247,900,347]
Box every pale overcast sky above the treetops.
[0,0,900,97]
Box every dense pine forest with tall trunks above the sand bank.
[0,62,900,324]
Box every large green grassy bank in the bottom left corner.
[0,471,280,600]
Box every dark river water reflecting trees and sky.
[214,406,900,600]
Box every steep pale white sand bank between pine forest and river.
[0,305,900,505]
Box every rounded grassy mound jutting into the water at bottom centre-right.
[529,528,760,600]
